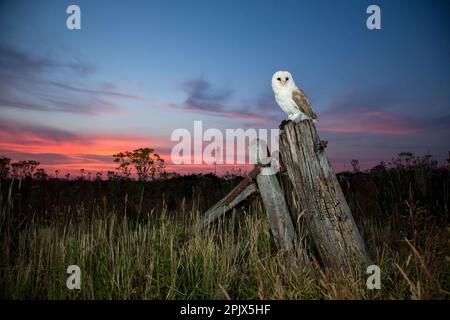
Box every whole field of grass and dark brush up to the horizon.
[0,163,450,299]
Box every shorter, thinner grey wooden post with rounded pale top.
[249,139,309,267]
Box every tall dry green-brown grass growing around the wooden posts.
[0,166,450,299]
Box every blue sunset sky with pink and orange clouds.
[0,0,450,173]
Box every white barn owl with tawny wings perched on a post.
[272,71,317,123]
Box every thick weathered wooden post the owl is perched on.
[280,120,369,269]
